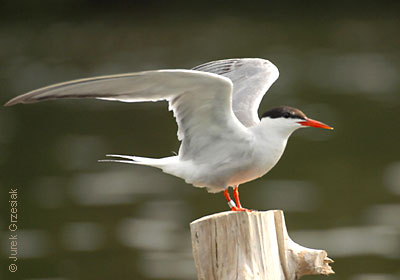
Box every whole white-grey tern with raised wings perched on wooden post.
[5,58,332,211]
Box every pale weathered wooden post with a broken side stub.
[190,210,334,280]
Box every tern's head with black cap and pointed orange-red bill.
[261,106,333,135]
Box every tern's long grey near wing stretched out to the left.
[6,70,246,158]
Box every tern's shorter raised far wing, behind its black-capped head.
[193,58,279,127]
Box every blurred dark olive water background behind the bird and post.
[0,0,400,280]
